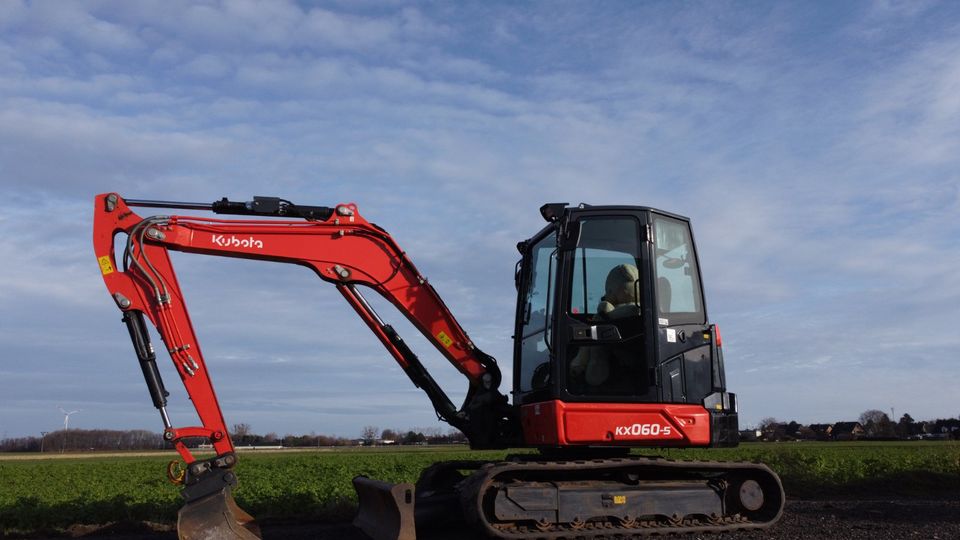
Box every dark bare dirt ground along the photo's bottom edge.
[0,500,960,540]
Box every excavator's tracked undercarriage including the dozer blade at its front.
[355,456,784,540]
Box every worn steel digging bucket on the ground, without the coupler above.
[177,486,261,540]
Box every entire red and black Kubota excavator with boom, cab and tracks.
[93,193,784,540]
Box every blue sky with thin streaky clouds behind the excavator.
[0,0,960,436]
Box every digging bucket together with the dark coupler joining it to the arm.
[177,462,261,540]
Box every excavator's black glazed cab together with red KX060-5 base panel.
[513,204,737,447]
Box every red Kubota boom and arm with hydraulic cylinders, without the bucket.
[94,193,513,464]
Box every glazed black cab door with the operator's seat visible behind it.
[557,210,656,402]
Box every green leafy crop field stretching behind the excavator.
[0,442,960,532]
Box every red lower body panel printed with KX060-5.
[520,400,711,447]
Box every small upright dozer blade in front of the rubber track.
[353,476,417,540]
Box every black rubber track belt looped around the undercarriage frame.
[460,457,785,540]
